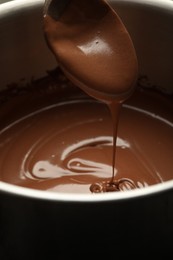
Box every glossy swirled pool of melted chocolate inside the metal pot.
[0,70,173,193]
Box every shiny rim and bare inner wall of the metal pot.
[0,0,173,201]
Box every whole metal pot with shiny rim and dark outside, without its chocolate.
[0,0,173,259]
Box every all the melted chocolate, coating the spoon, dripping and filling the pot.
[0,0,173,193]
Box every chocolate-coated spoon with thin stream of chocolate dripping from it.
[44,0,137,192]
